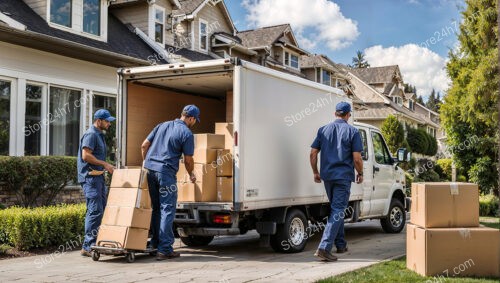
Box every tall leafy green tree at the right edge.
[441,0,500,195]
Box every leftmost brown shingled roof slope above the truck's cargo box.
[237,24,292,48]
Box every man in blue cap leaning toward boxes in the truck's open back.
[141,105,200,260]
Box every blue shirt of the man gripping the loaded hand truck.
[77,125,106,183]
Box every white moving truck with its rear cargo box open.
[117,59,407,252]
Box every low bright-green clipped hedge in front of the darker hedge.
[0,204,86,250]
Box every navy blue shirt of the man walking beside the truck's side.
[311,119,363,182]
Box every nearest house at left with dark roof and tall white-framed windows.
[0,0,154,156]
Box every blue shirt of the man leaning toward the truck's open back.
[144,119,194,178]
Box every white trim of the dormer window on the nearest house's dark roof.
[46,0,108,41]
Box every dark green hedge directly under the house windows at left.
[0,156,77,207]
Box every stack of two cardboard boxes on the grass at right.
[406,183,500,276]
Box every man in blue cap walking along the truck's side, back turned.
[310,101,363,261]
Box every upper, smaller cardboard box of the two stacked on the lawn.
[411,183,479,228]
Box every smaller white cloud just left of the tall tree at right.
[364,44,450,98]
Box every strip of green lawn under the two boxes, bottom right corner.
[318,257,498,283]
